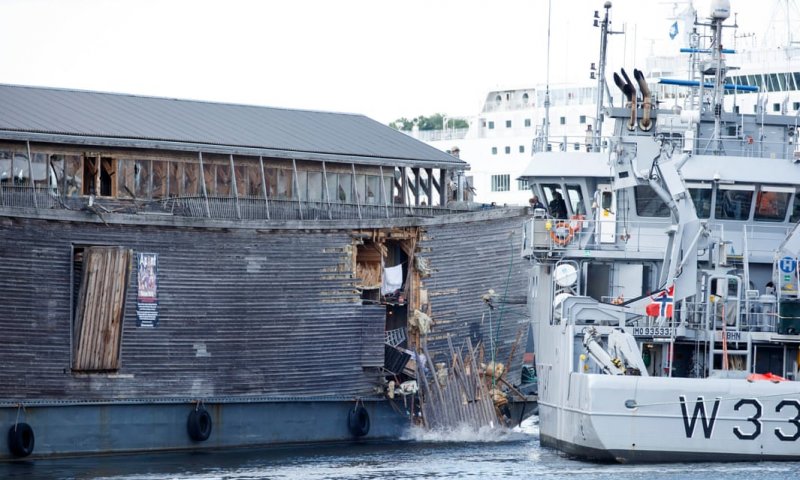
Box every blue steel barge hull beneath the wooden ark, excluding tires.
[0,398,409,460]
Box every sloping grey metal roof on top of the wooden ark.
[0,84,466,168]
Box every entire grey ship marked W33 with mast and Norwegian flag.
[523,1,800,462]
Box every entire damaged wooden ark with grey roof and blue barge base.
[0,85,527,459]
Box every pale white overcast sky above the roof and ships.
[0,0,796,123]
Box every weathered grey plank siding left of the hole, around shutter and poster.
[0,218,385,400]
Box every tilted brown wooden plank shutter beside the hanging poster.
[73,247,132,371]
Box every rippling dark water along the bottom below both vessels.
[0,423,800,480]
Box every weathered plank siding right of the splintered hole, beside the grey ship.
[419,218,529,383]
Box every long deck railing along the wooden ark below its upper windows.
[0,185,486,221]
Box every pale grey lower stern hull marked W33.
[540,374,800,463]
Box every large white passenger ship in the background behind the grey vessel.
[413,0,800,205]
